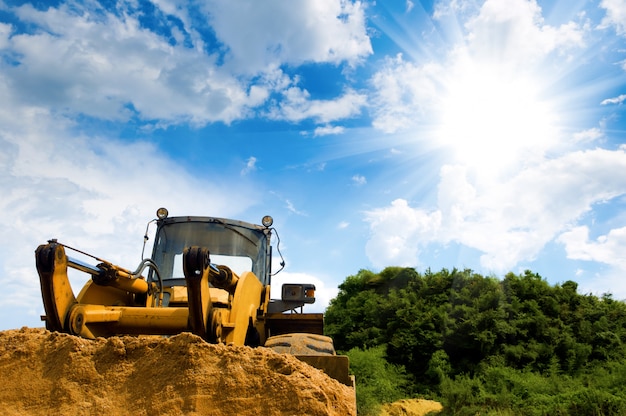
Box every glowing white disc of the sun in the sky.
[435,55,558,173]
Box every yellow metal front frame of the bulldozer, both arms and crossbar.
[36,242,269,345]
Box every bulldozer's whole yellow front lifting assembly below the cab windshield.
[36,240,265,345]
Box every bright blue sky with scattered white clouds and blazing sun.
[0,0,626,329]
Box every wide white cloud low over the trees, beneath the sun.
[365,149,626,272]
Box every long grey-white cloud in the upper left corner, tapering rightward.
[3,5,258,125]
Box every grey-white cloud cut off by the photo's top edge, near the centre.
[197,0,373,73]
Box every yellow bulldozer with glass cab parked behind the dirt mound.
[35,208,354,388]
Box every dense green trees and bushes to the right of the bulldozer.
[325,267,626,416]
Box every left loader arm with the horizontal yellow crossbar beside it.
[35,240,189,339]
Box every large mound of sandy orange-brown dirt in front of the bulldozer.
[0,328,356,416]
